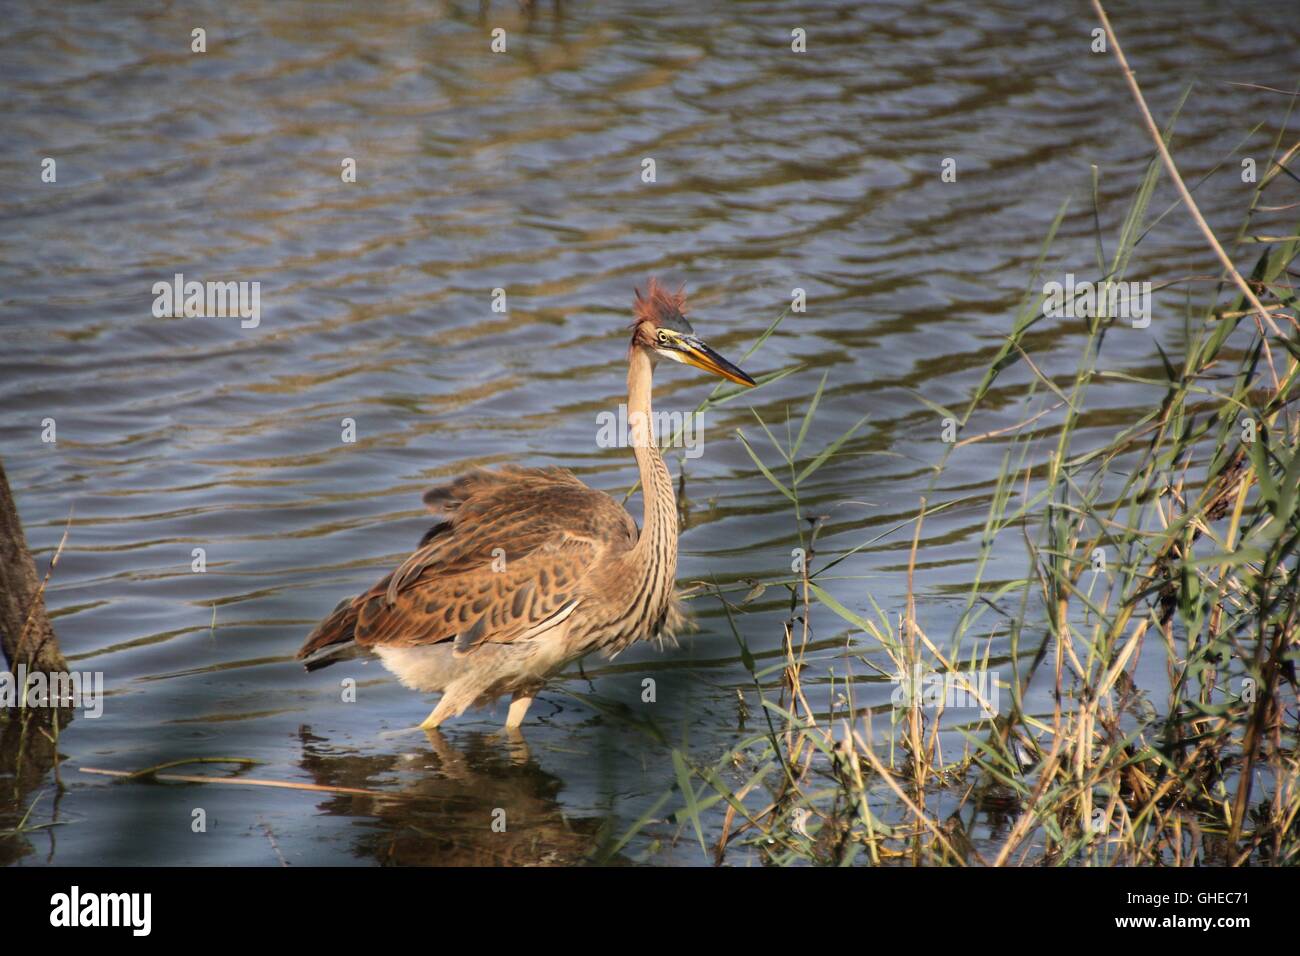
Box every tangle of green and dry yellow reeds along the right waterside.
[615,89,1300,865]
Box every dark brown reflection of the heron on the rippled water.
[299,727,618,866]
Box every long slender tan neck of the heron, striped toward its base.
[628,347,677,574]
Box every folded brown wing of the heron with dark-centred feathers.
[352,467,637,654]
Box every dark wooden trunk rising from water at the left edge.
[0,462,68,674]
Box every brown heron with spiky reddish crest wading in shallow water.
[296,278,757,734]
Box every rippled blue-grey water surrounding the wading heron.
[0,0,1300,865]
